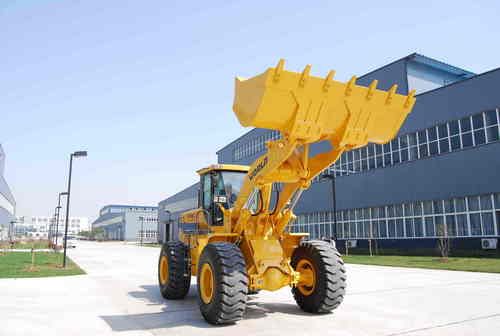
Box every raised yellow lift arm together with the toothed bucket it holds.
[230,60,415,235]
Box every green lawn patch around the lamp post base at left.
[0,251,85,278]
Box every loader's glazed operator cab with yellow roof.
[198,164,248,225]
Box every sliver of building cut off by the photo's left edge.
[0,144,16,240]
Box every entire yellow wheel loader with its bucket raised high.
[158,60,415,324]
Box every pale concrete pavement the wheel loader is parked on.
[0,242,500,336]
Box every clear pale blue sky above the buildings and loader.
[0,0,500,217]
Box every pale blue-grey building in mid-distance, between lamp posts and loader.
[92,205,158,242]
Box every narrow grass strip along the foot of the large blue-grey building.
[343,255,500,273]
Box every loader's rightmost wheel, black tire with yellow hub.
[291,240,346,313]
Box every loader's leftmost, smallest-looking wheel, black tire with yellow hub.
[158,241,191,300]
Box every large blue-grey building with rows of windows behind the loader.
[158,53,500,250]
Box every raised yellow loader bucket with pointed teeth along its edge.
[233,60,415,147]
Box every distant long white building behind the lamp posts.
[14,216,90,239]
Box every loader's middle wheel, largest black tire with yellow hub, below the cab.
[197,242,248,324]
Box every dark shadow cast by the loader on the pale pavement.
[101,284,320,331]
